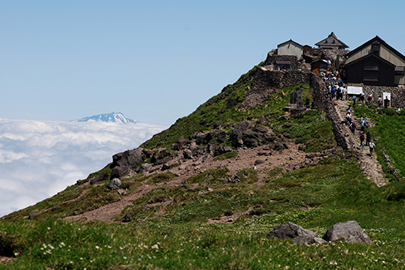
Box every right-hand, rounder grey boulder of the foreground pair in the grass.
[322,220,373,244]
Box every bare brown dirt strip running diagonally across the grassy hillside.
[65,142,330,222]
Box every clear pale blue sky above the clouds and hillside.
[0,0,405,125]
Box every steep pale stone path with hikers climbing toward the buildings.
[335,100,388,187]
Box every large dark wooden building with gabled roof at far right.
[345,36,405,86]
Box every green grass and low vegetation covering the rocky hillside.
[0,67,405,269]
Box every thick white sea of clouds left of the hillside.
[0,118,166,217]
